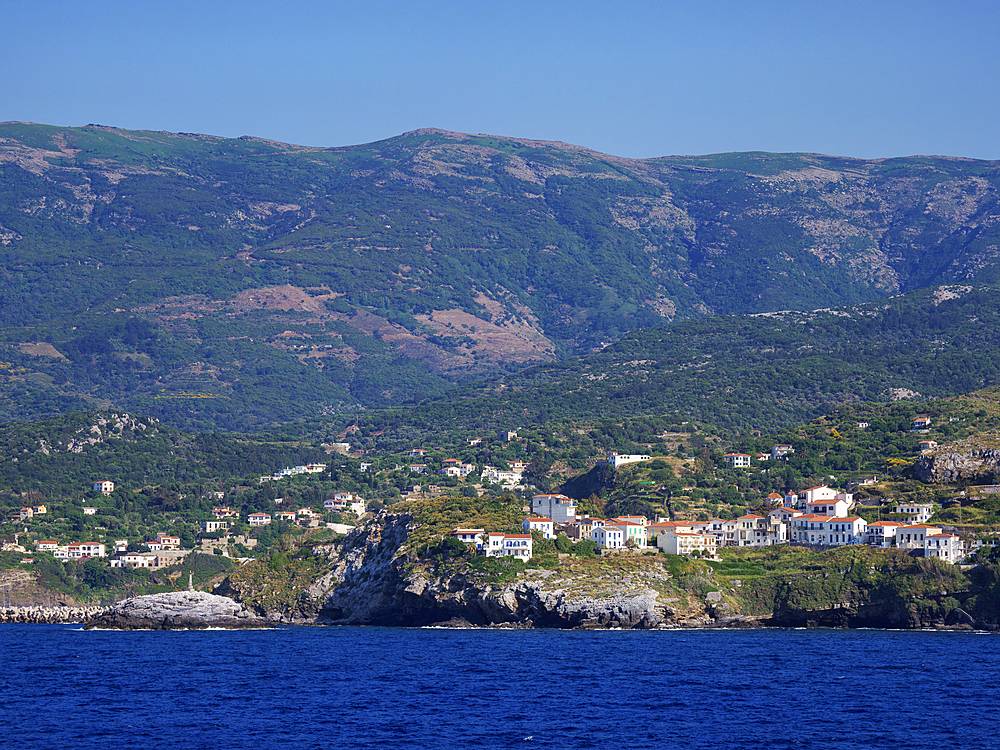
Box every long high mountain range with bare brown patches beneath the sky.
[0,123,1000,429]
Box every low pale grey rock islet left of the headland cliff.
[86,591,272,630]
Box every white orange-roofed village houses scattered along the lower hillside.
[8,416,993,569]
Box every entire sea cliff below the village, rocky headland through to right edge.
[216,513,1000,629]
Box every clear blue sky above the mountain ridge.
[7,0,1000,159]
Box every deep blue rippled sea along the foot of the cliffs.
[0,625,1000,750]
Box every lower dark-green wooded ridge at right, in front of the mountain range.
[352,285,1000,440]
